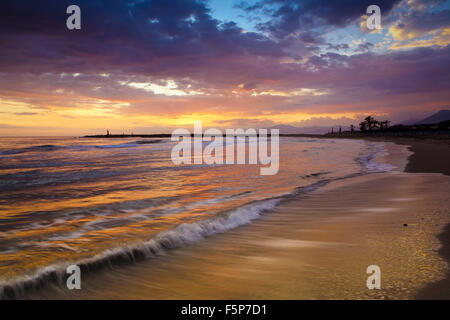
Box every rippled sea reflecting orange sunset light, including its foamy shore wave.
[0,137,393,294]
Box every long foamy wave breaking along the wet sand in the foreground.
[0,178,330,299]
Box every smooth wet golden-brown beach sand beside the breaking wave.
[27,141,450,299]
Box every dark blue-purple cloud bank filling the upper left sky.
[0,0,282,76]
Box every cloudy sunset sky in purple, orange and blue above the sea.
[0,0,450,136]
